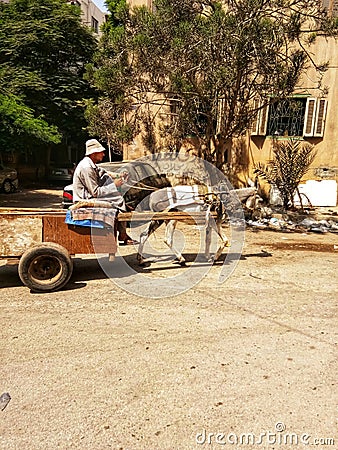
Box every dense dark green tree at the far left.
[0,0,97,158]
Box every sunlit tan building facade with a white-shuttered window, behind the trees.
[124,0,338,204]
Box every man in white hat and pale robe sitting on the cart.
[73,139,137,245]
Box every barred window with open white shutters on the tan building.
[251,97,327,137]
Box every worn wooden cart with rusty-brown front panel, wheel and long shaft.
[0,208,214,292]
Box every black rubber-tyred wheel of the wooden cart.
[19,242,73,292]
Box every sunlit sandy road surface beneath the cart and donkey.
[0,189,338,450]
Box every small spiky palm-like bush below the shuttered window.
[254,140,316,209]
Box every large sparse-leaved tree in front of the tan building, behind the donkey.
[91,0,337,168]
